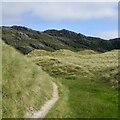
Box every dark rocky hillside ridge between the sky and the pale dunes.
[2,26,120,54]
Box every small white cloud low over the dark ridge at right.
[96,30,118,39]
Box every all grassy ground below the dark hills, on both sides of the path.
[2,42,119,118]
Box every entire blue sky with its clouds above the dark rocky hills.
[2,0,118,39]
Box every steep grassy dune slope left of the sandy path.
[2,43,52,118]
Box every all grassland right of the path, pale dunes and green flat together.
[28,50,119,118]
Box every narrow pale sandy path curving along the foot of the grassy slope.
[25,82,59,118]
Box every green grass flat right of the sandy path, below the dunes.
[47,77,118,118]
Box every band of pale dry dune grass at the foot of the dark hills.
[28,49,118,77]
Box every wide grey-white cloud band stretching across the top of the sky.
[3,2,117,21]
